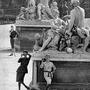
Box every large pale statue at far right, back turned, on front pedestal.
[67,0,89,52]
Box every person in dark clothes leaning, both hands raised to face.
[16,50,31,90]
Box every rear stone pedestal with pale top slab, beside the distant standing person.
[15,20,50,51]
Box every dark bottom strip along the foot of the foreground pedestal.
[40,83,90,90]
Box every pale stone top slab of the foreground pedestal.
[32,50,90,62]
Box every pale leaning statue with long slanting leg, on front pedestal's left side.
[39,10,65,51]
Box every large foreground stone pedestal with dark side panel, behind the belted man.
[32,50,90,90]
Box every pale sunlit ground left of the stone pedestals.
[0,25,32,90]
